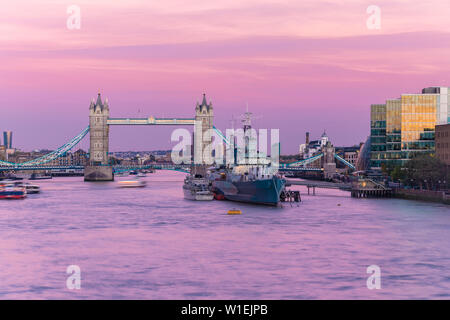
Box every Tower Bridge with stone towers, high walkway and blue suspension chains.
[0,93,355,181]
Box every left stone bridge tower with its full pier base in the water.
[84,93,114,181]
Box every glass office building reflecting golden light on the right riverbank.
[370,87,450,168]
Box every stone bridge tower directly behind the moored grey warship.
[194,94,214,167]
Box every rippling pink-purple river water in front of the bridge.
[0,171,450,299]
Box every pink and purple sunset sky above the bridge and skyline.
[0,0,450,153]
